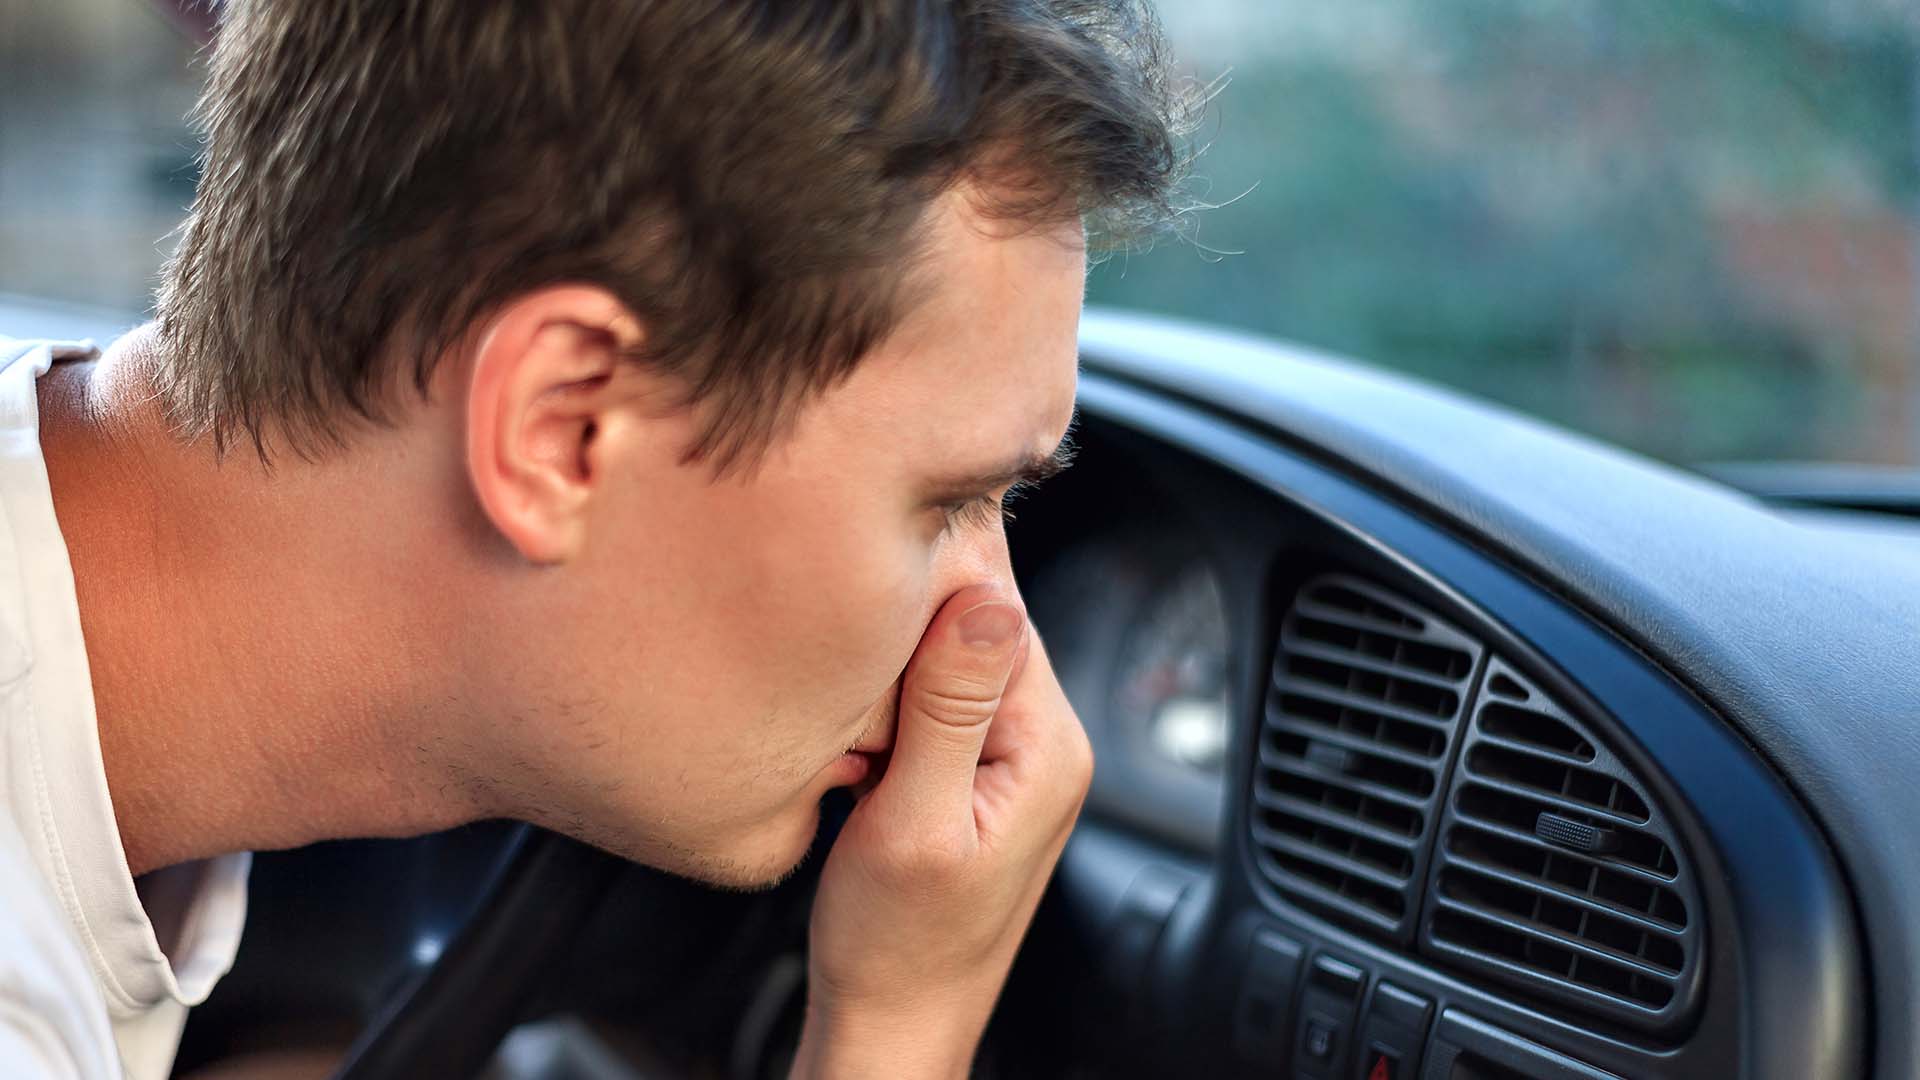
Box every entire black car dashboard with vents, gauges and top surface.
[1002,315,1920,1080]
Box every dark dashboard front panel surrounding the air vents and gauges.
[1016,371,1862,1078]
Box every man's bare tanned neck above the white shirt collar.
[40,331,482,874]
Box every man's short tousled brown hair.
[157,0,1194,465]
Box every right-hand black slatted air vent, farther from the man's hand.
[1421,655,1703,1030]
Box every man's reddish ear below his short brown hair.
[467,284,641,563]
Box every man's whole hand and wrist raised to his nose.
[793,586,1092,1076]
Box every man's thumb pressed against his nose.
[887,588,1027,813]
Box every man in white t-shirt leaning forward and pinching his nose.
[0,0,1183,1080]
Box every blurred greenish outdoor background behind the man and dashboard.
[0,0,1920,465]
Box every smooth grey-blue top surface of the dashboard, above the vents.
[1083,313,1920,1080]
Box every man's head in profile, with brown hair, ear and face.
[145,0,1185,884]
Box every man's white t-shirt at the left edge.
[0,338,252,1080]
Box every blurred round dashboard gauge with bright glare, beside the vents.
[1114,565,1227,778]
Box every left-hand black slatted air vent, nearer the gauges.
[1252,575,1482,942]
